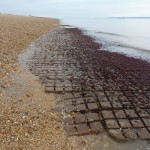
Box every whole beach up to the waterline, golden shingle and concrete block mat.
[0,14,150,150]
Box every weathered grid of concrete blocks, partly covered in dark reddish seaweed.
[25,28,150,141]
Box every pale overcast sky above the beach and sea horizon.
[0,0,150,19]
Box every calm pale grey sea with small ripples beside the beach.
[62,18,150,61]
